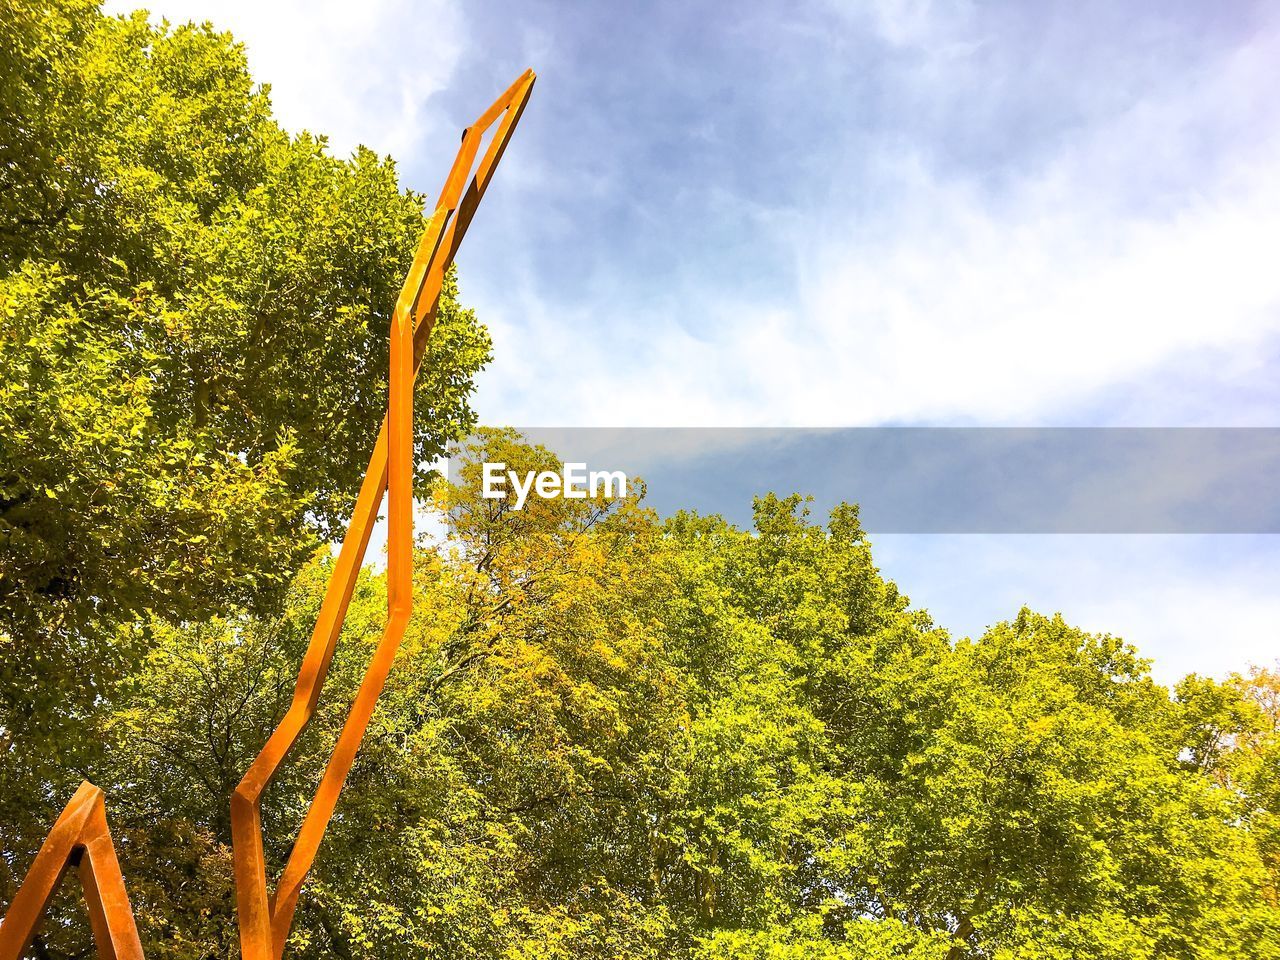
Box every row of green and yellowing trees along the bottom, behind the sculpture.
[12,431,1280,960]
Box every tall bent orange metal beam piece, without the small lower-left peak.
[232,70,534,960]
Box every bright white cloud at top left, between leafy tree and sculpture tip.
[105,0,463,157]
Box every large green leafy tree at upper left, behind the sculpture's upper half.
[0,0,489,776]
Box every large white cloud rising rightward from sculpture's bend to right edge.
[467,14,1280,425]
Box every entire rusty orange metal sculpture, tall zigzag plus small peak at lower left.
[0,70,534,960]
